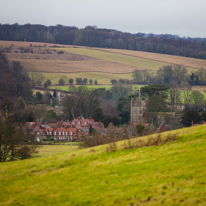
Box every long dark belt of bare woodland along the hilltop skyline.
[0,24,206,59]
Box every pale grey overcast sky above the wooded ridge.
[0,0,206,38]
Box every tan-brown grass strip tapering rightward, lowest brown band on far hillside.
[11,58,142,74]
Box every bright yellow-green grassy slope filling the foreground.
[0,125,206,206]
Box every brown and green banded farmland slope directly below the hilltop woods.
[0,41,201,73]
